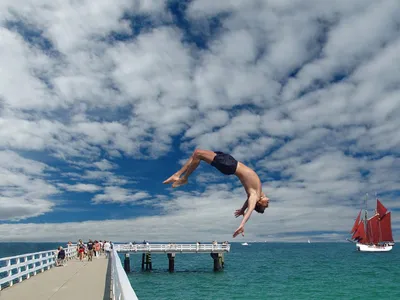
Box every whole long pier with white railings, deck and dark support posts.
[0,244,230,300]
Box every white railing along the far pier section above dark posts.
[114,244,231,253]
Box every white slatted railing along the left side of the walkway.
[0,248,76,291]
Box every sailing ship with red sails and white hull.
[349,199,394,252]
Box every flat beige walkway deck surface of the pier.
[0,256,111,300]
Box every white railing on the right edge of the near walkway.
[111,248,138,300]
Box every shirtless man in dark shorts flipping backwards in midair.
[163,149,269,237]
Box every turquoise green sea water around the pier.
[0,243,400,300]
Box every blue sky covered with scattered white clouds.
[0,0,400,241]
